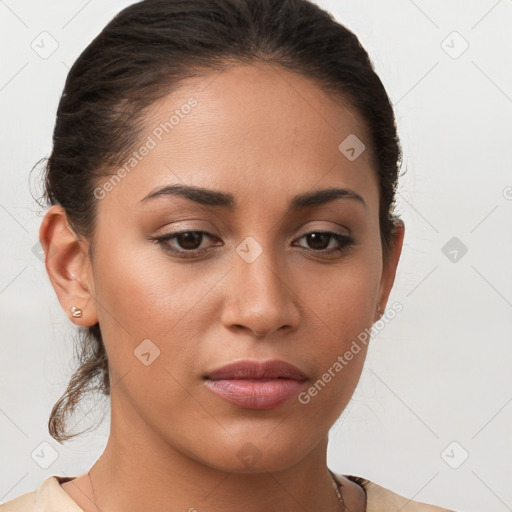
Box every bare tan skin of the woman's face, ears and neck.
[40,64,405,512]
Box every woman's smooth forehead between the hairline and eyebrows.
[99,64,378,214]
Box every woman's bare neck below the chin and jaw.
[86,394,343,512]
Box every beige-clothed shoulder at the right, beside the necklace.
[335,473,455,512]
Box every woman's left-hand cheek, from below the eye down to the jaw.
[89,245,211,422]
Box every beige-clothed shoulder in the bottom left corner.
[0,475,83,512]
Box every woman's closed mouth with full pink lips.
[203,359,308,409]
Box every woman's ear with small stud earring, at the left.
[39,205,98,327]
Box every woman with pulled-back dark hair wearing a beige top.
[1,0,460,512]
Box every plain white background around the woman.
[0,0,512,512]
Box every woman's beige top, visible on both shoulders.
[0,475,454,512]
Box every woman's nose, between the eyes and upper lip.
[221,243,301,337]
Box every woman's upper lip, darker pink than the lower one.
[205,359,307,380]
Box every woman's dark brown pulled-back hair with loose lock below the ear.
[37,0,402,442]
